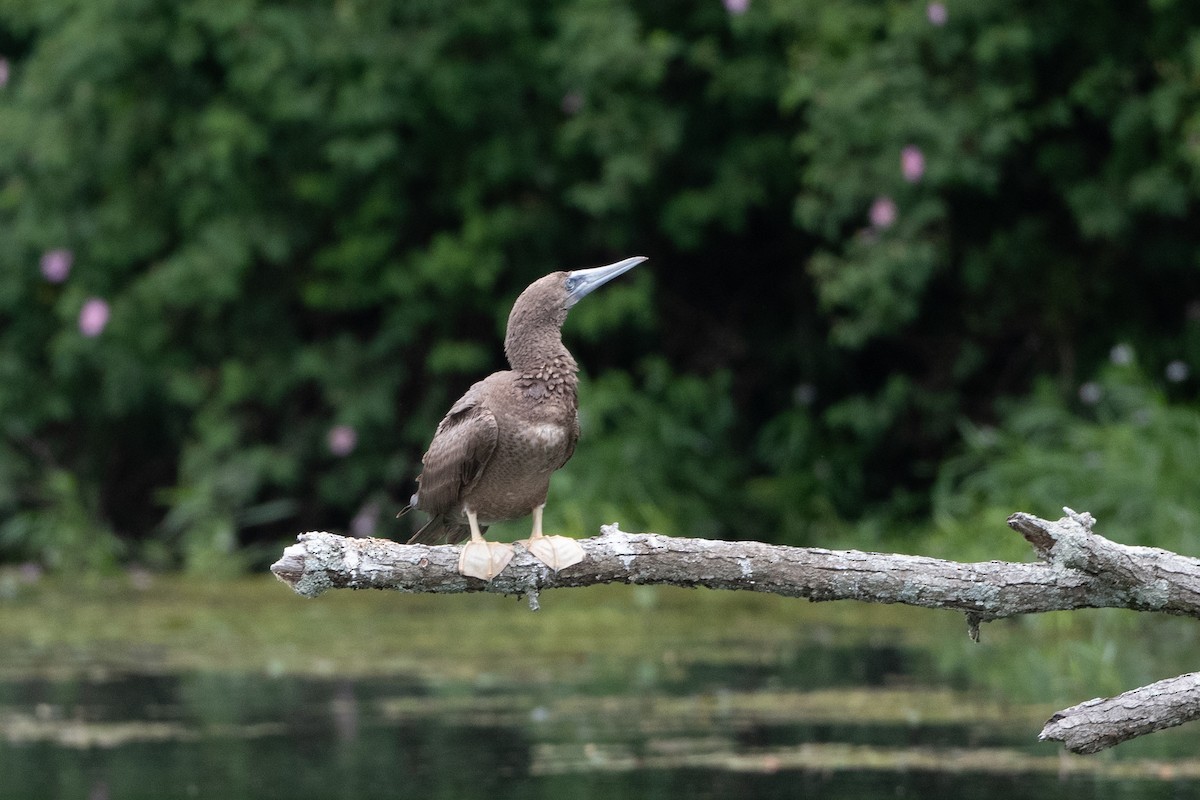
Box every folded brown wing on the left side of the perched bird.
[416,384,499,515]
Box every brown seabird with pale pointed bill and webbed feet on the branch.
[409,255,646,581]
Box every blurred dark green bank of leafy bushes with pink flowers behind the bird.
[0,0,1200,570]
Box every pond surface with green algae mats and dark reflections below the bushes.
[0,576,1200,800]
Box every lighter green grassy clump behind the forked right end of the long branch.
[934,365,1200,553]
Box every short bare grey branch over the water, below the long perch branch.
[1038,672,1200,753]
